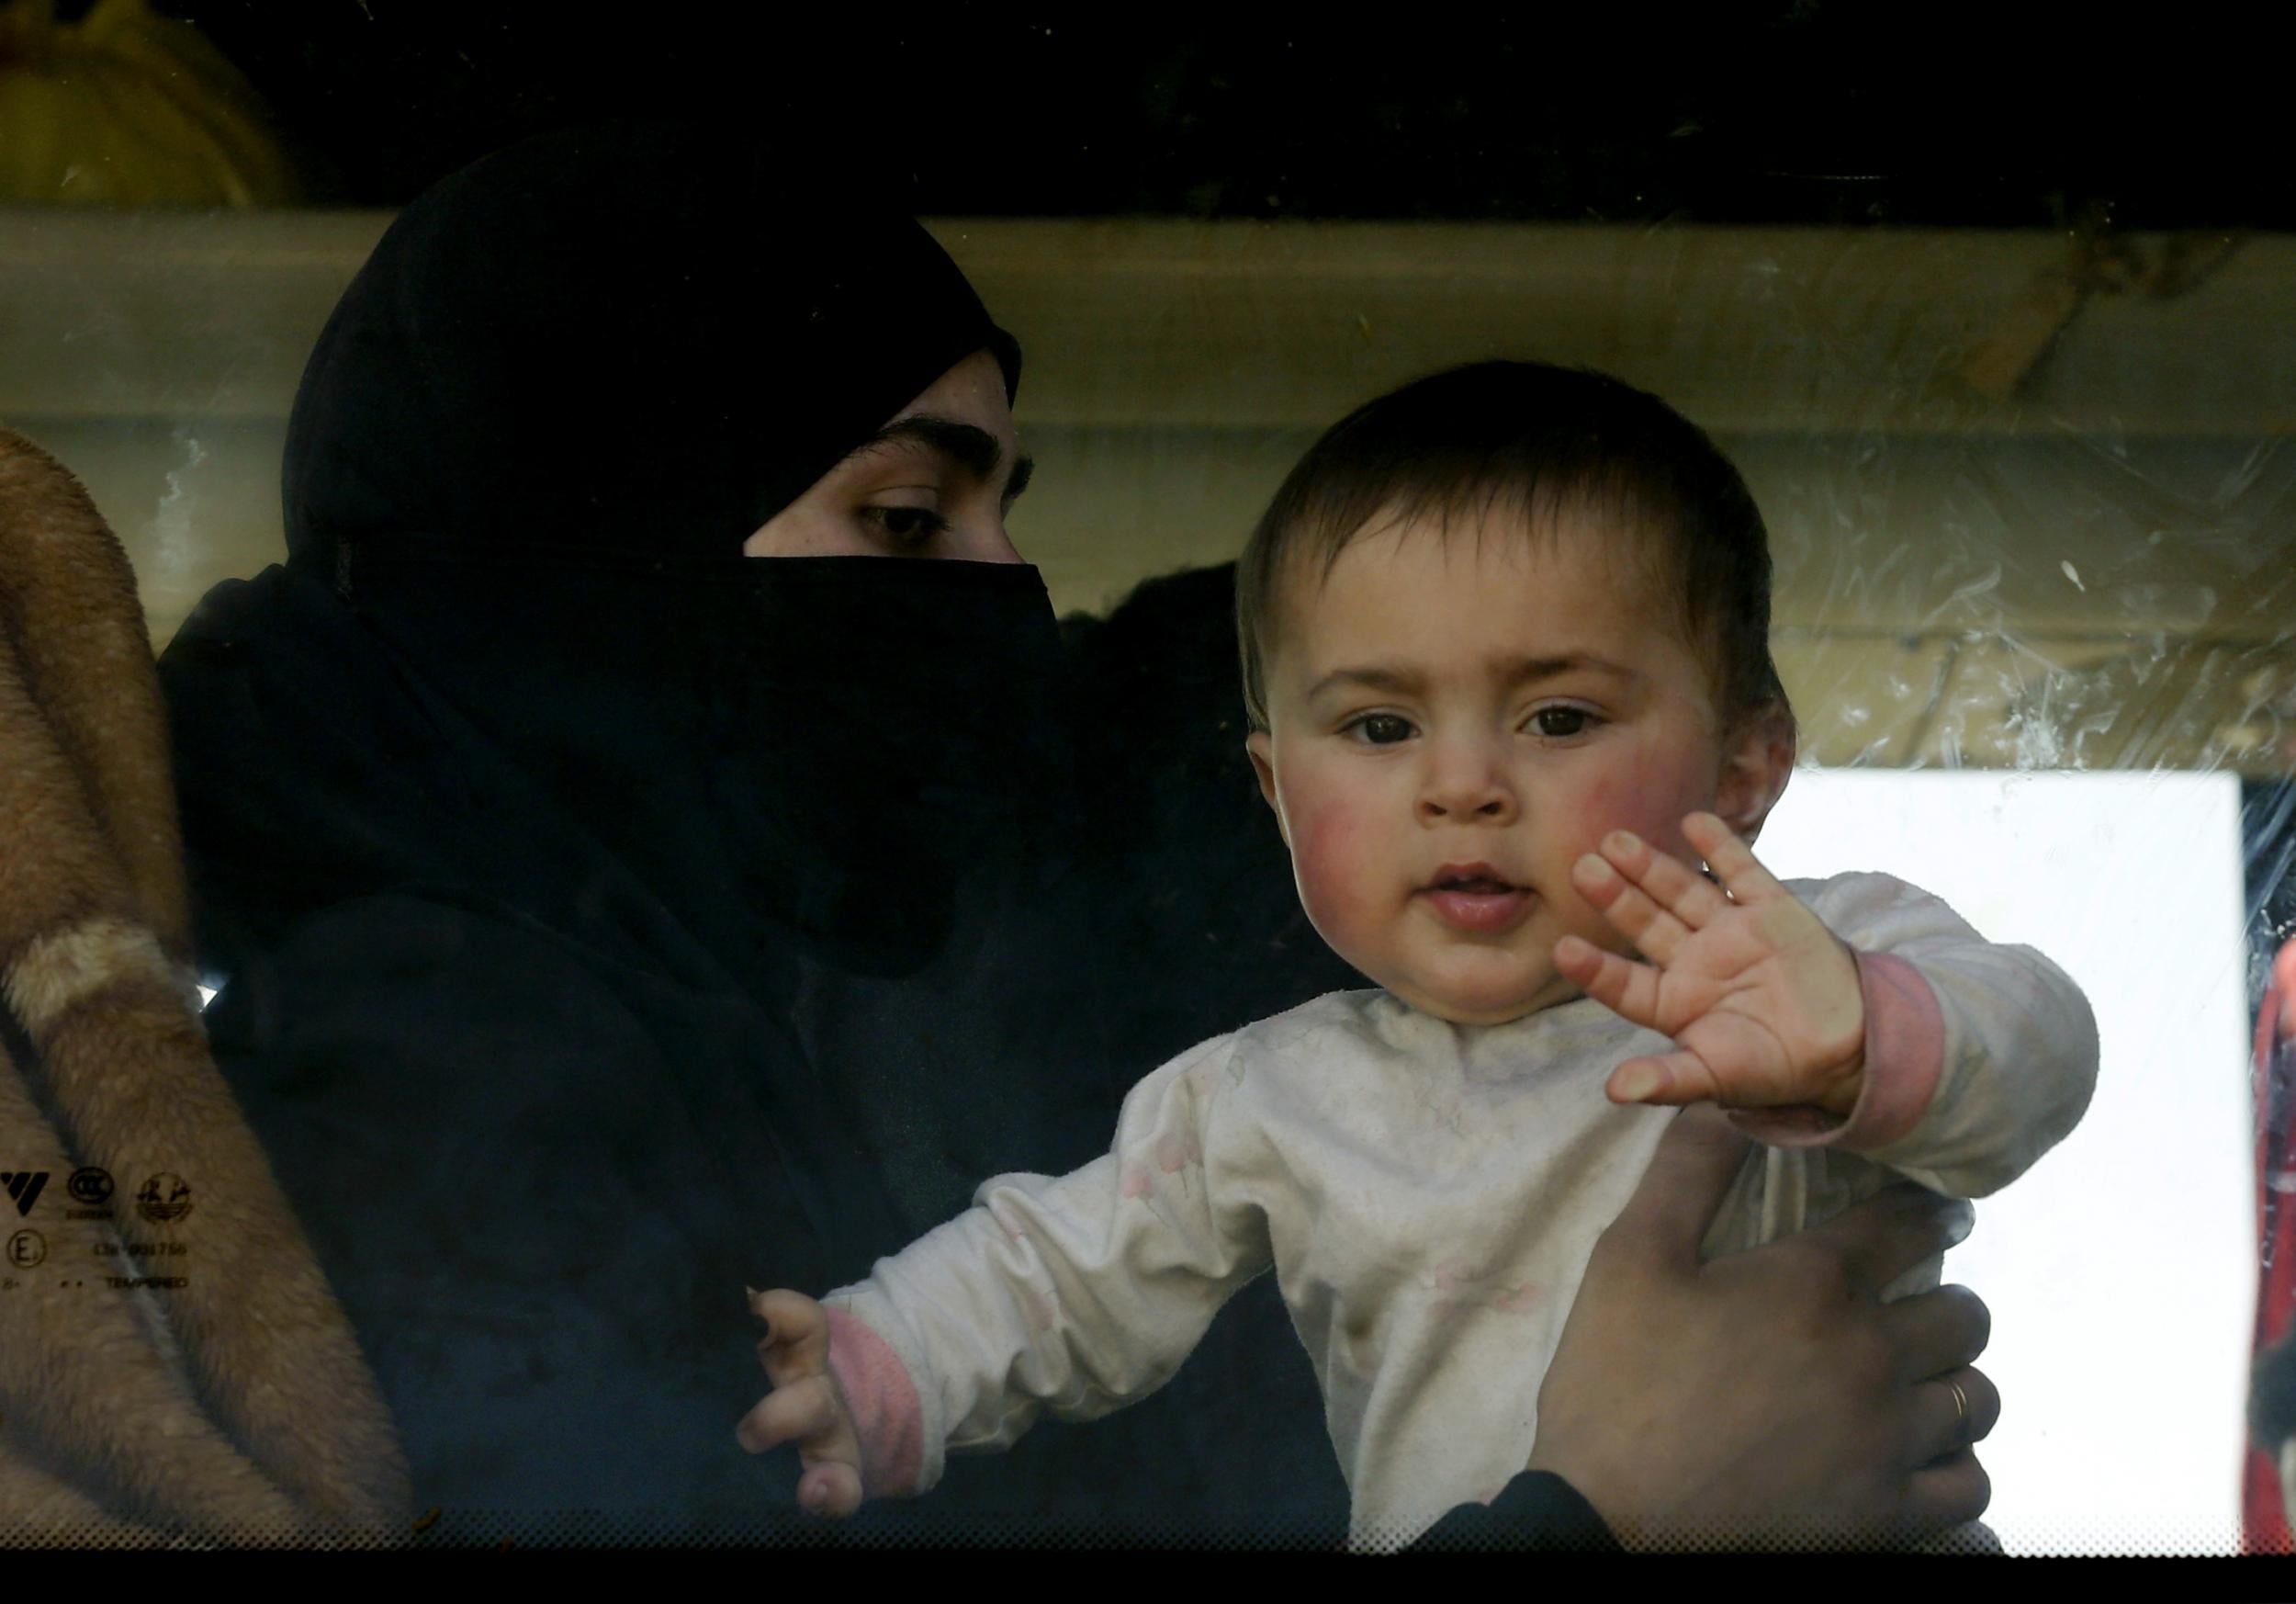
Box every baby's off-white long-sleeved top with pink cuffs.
[825,874,2097,1546]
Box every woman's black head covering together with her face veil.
[264,124,1064,975]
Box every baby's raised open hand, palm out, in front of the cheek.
[1555,814,1864,1114]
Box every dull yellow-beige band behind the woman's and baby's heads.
[13,211,2296,776]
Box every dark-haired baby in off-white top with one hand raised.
[739,363,2097,1546]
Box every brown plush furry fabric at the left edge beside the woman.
[0,430,409,1546]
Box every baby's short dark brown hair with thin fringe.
[1235,361,1791,729]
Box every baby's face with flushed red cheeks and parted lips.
[1252,522,1729,1025]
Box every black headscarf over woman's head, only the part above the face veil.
[285,124,1019,577]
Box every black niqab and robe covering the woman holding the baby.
[161,127,1185,1526]
